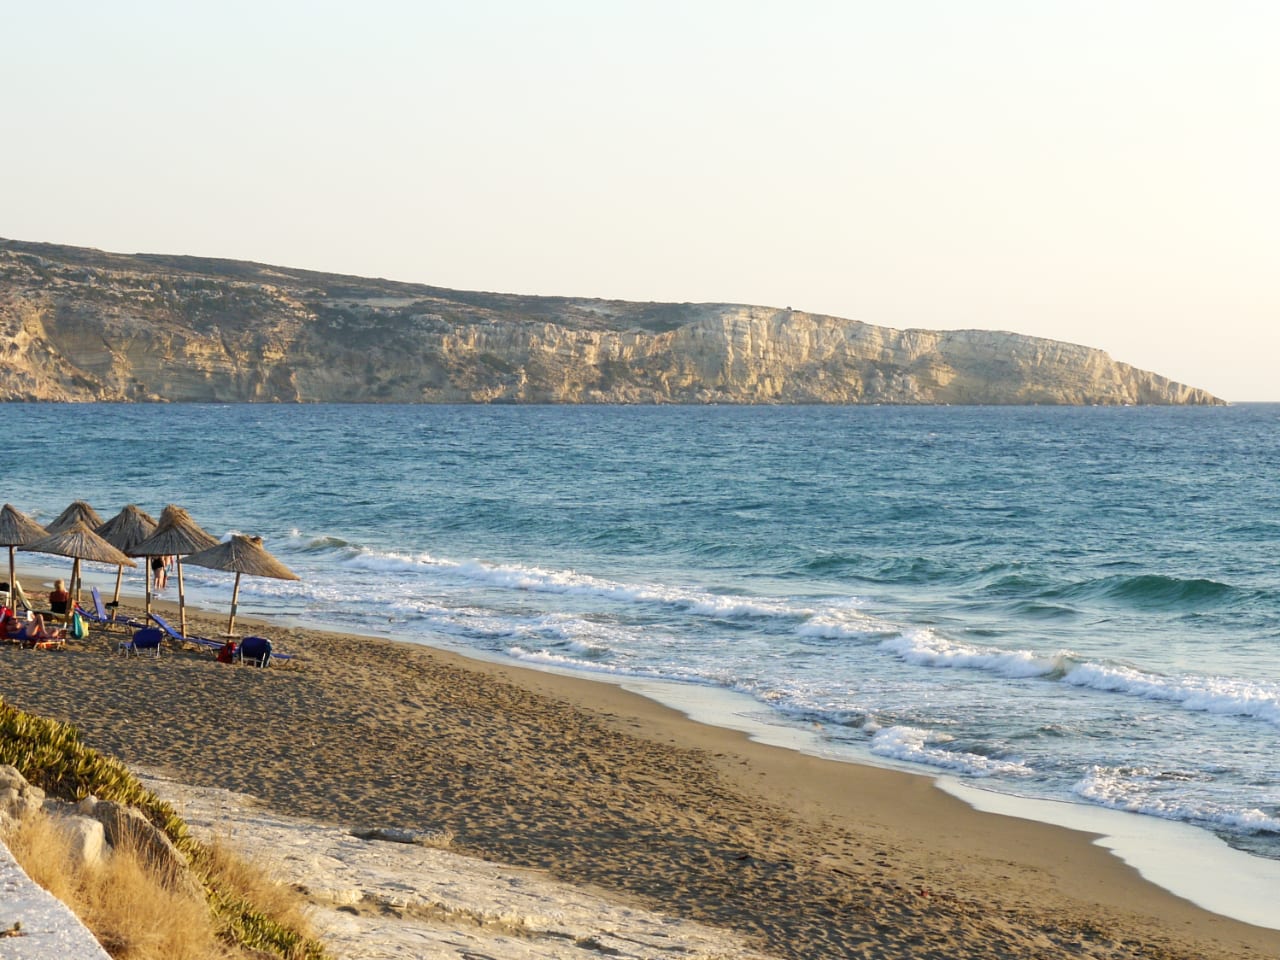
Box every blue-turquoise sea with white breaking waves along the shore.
[0,404,1280,858]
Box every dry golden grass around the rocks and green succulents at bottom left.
[4,814,307,960]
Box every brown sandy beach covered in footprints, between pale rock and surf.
[0,593,1280,960]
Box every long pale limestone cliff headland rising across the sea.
[0,241,1219,404]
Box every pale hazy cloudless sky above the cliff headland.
[0,0,1280,401]
